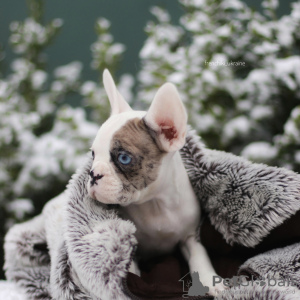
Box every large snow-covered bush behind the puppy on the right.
[138,0,300,171]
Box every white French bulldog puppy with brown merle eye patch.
[88,70,224,295]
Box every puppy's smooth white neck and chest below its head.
[121,145,200,256]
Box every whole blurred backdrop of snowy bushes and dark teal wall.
[0,0,300,278]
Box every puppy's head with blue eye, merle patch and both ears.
[88,70,187,205]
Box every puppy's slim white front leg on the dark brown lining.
[180,235,226,296]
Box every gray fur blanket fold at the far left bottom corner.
[4,215,52,300]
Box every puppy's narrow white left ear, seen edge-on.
[103,69,132,115]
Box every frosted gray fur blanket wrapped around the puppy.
[5,131,300,300]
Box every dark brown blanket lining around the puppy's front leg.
[127,211,300,300]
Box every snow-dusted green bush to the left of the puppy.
[0,0,133,234]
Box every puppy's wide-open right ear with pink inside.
[145,83,187,152]
